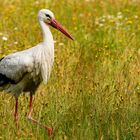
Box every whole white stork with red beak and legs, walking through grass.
[0,9,73,133]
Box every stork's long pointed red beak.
[49,19,73,40]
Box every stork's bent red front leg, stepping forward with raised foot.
[28,94,53,136]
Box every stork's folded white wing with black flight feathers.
[0,52,33,86]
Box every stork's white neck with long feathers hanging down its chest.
[39,20,54,83]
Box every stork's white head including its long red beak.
[38,9,73,40]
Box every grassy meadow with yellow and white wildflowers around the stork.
[0,0,140,140]
